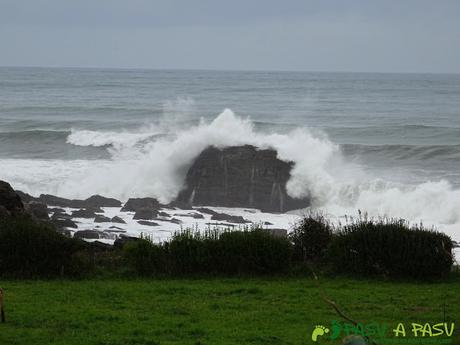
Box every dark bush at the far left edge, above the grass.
[0,216,83,278]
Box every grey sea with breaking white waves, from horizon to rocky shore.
[0,67,460,231]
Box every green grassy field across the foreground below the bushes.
[0,276,460,345]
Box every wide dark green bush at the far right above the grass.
[329,218,453,279]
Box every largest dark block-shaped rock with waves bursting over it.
[177,145,310,212]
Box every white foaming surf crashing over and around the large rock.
[1,109,460,243]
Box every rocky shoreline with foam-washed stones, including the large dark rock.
[0,145,310,244]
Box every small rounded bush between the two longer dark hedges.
[290,213,333,262]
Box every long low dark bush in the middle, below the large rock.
[124,229,292,275]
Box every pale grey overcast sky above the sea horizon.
[0,0,460,73]
